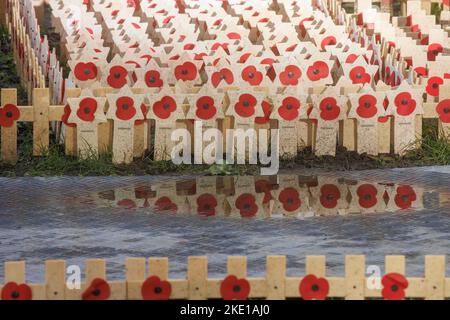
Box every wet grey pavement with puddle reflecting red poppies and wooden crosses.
[0,167,450,282]
